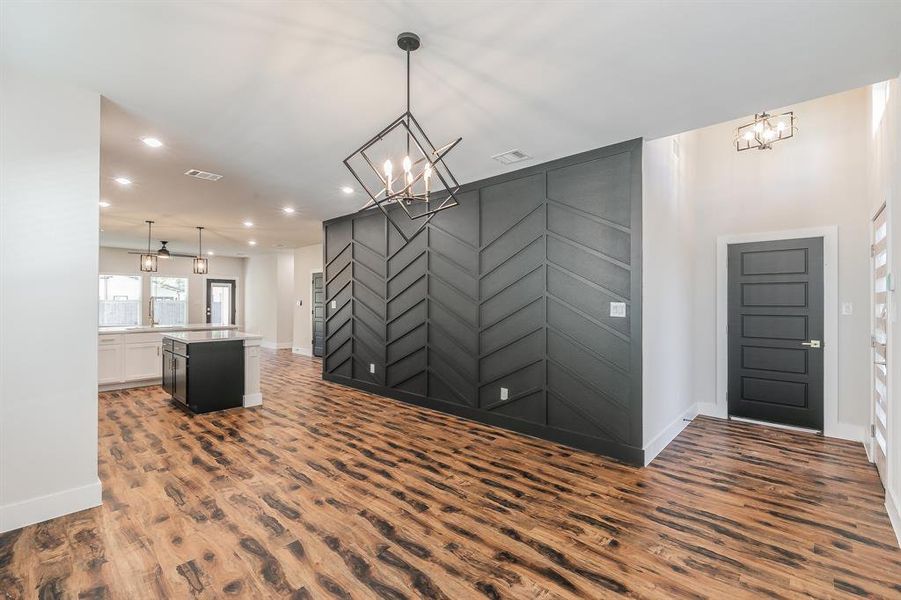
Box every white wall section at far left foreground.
[0,67,101,531]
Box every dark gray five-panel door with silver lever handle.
[729,238,823,430]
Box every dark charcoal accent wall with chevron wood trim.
[323,140,643,464]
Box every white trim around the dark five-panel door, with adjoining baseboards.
[712,225,863,442]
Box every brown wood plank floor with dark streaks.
[0,351,901,599]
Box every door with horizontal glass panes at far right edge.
[870,206,889,482]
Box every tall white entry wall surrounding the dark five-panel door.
[680,88,871,440]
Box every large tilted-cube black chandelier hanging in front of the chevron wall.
[344,32,463,241]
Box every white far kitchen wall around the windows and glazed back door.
[100,248,246,326]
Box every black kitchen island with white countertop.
[162,330,263,413]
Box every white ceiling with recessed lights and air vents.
[0,0,901,254]
